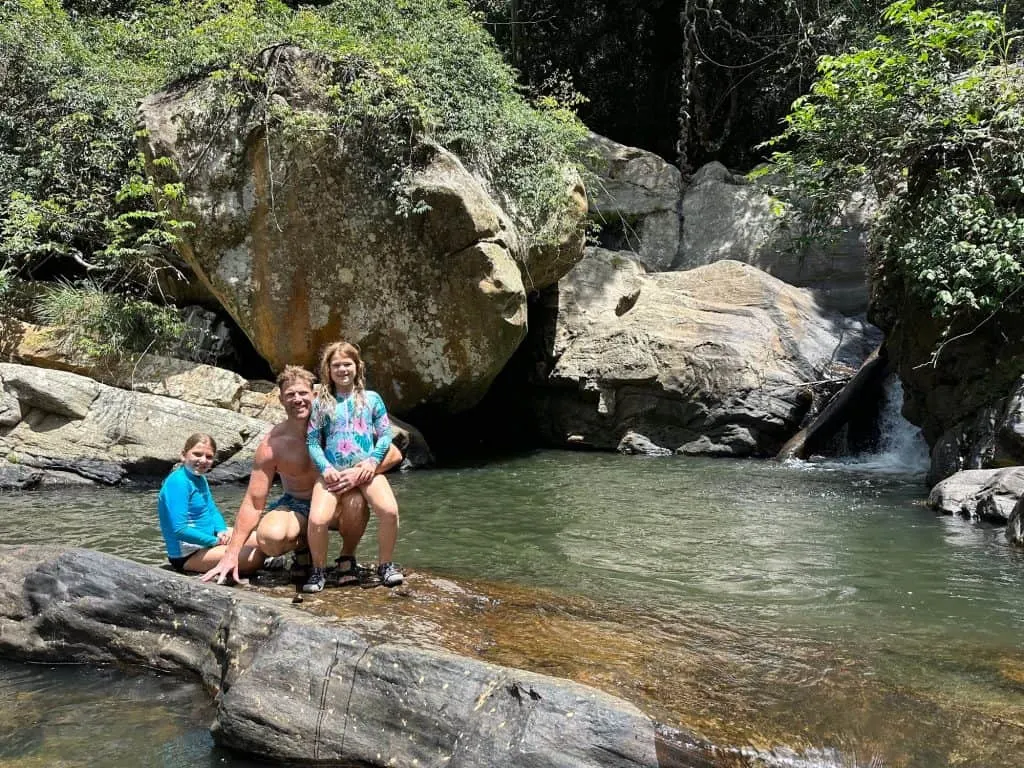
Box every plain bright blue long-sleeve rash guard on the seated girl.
[158,465,227,557]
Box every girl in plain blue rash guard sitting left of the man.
[157,433,265,573]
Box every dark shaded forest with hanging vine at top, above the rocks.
[472,0,897,168]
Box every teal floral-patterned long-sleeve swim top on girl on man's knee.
[306,390,391,474]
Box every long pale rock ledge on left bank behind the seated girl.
[0,364,270,484]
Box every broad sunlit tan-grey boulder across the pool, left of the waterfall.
[537,249,880,456]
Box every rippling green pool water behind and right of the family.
[0,452,1024,768]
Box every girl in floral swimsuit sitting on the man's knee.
[302,341,402,592]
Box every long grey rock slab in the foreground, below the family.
[0,546,745,768]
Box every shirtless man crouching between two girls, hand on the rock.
[203,366,401,584]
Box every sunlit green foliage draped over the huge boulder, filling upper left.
[0,0,583,315]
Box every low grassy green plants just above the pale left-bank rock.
[35,281,185,361]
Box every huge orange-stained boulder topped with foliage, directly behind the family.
[140,46,586,413]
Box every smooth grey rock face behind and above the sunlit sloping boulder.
[674,163,873,314]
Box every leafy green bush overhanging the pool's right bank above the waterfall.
[772,0,1024,332]
